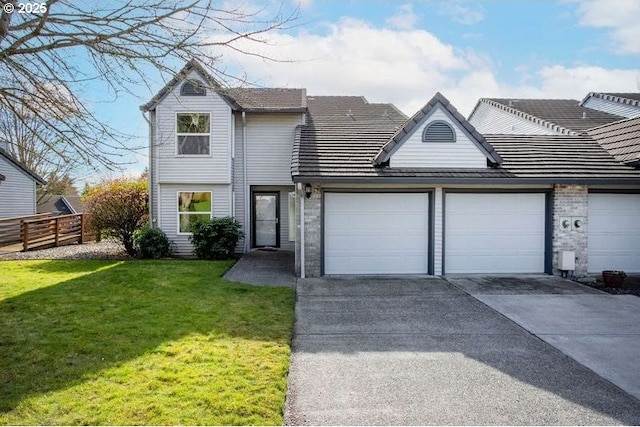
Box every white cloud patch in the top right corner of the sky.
[577,0,640,55]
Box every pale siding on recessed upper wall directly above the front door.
[247,113,303,185]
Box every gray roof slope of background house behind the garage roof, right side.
[480,98,624,135]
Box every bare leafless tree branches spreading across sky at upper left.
[0,0,297,172]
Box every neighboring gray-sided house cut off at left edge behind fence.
[0,148,46,218]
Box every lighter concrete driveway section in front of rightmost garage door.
[448,276,640,399]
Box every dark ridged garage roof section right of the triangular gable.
[485,135,640,180]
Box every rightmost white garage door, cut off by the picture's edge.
[587,193,640,273]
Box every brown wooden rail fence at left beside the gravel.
[0,213,100,251]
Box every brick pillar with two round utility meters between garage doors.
[553,184,588,277]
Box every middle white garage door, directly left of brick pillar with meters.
[444,193,545,274]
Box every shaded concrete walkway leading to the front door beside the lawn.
[224,249,296,288]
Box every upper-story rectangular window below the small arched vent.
[176,113,211,156]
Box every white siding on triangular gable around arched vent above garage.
[390,109,487,168]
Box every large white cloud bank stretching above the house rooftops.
[214,14,640,115]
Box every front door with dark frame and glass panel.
[253,192,280,248]
